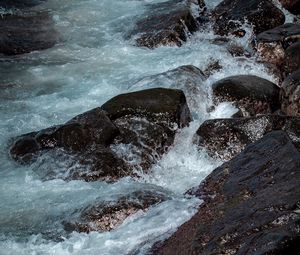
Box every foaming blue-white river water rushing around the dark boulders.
[0,0,282,255]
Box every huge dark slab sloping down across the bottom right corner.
[152,131,300,255]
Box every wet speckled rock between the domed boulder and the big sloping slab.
[197,115,300,160]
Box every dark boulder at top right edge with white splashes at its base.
[212,0,285,36]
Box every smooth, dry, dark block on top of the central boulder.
[101,88,191,127]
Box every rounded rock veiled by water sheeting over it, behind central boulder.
[130,65,209,112]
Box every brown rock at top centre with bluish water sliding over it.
[129,0,198,49]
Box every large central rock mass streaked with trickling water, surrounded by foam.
[10,88,191,181]
